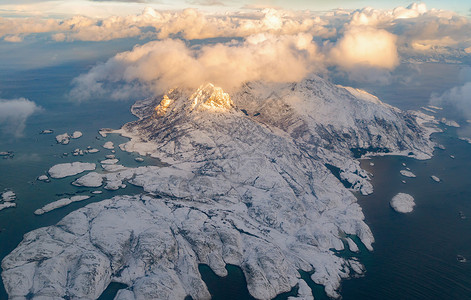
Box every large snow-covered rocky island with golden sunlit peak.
[2,75,433,299]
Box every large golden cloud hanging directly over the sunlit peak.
[71,34,322,100]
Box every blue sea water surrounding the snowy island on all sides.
[0,62,471,300]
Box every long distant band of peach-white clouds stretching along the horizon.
[0,1,471,64]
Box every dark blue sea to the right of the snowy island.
[342,130,471,299]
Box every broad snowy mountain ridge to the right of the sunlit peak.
[233,75,432,159]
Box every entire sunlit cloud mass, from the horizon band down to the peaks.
[0,3,471,100]
